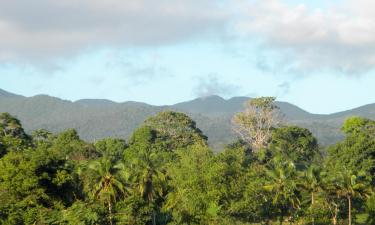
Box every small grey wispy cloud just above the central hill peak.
[193,74,240,97]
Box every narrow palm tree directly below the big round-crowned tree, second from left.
[132,148,166,225]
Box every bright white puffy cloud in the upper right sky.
[236,0,375,73]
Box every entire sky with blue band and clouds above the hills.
[0,0,375,114]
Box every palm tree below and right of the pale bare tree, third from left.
[264,159,300,224]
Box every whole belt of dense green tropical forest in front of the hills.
[0,97,375,225]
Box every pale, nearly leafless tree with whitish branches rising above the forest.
[232,97,279,151]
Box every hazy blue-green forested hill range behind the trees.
[0,89,375,149]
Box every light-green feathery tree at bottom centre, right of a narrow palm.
[163,145,220,224]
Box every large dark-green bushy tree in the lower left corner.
[0,146,81,224]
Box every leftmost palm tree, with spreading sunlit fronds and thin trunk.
[88,158,125,224]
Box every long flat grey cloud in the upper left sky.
[0,0,227,61]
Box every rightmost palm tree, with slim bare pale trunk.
[334,168,369,225]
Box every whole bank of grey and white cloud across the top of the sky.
[0,0,375,73]
